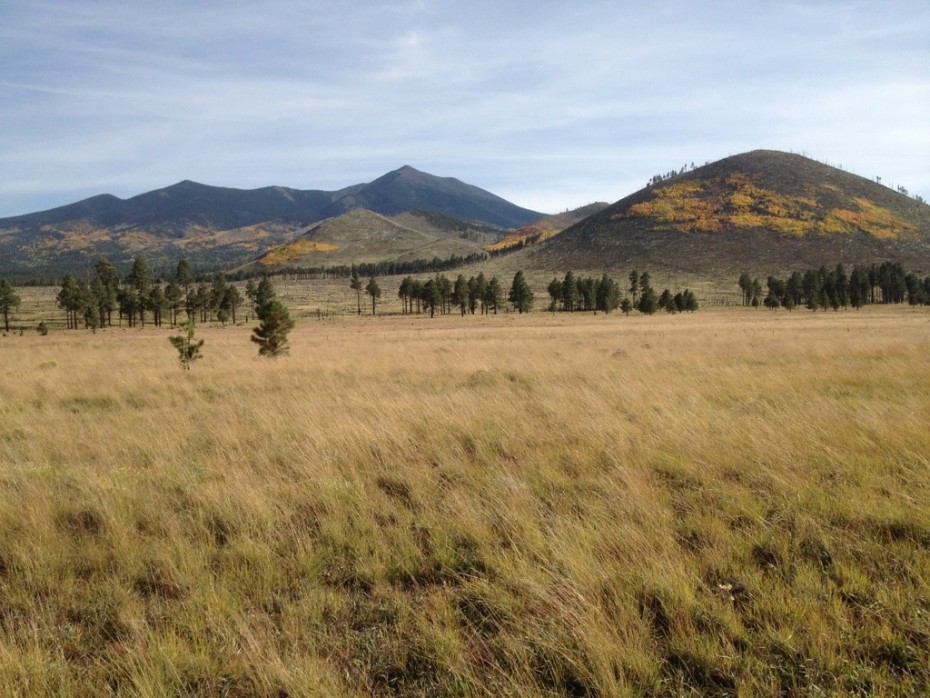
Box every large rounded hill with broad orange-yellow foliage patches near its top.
[525,150,930,276]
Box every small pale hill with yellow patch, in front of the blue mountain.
[254,209,481,270]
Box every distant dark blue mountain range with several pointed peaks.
[0,166,542,279]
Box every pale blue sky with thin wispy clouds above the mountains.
[0,0,930,217]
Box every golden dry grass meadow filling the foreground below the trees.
[0,312,930,696]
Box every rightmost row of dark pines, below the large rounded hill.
[738,262,930,310]
